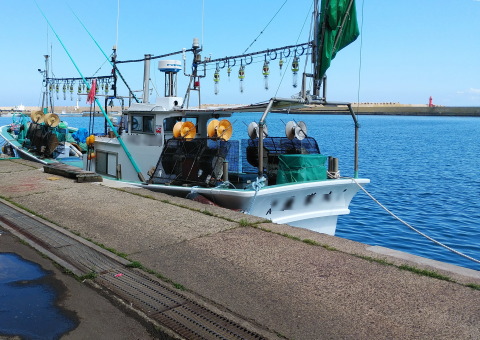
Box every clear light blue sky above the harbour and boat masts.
[0,0,480,106]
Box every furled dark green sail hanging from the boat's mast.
[315,0,360,80]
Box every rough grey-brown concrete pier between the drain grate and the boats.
[0,159,480,339]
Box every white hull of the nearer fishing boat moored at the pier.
[142,179,370,235]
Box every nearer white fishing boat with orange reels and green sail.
[79,0,369,235]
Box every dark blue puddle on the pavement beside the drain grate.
[0,253,77,339]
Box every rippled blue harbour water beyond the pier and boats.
[0,114,480,270]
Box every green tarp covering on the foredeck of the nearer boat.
[277,154,327,184]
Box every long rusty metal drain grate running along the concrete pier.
[0,203,265,340]
